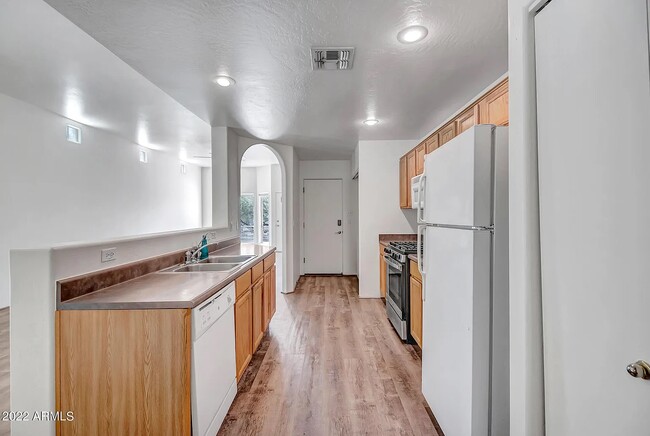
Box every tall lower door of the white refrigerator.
[422,227,492,436]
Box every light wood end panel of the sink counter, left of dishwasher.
[55,309,192,436]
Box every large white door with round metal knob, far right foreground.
[535,0,650,436]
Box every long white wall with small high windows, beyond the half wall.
[0,94,202,307]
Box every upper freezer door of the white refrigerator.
[424,124,494,227]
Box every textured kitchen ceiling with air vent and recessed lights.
[41,0,507,158]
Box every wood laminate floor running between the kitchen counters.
[219,276,437,436]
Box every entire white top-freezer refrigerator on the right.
[418,125,509,436]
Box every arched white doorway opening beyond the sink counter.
[239,144,287,292]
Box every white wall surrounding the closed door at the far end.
[299,160,358,275]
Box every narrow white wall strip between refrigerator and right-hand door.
[508,0,545,436]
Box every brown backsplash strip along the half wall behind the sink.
[56,237,239,305]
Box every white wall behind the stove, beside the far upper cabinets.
[358,140,417,298]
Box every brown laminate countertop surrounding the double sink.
[59,244,275,310]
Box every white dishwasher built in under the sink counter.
[192,283,237,436]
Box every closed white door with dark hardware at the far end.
[304,179,343,274]
